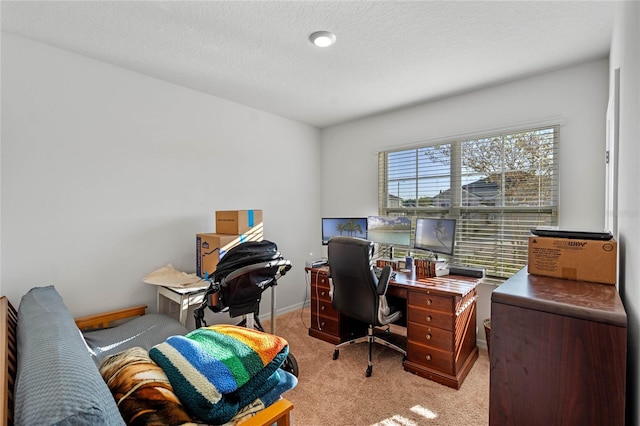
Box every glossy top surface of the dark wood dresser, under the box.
[491,267,627,327]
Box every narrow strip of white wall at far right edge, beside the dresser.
[610,2,640,425]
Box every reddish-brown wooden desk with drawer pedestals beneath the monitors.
[305,266,480,389]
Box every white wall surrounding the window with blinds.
[322,59,608,346]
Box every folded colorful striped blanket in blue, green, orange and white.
[149,324,289,424]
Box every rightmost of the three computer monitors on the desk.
[413,217,456,258]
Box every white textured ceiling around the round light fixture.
[0,0,615,128]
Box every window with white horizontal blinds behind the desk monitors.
[378,126,559,279]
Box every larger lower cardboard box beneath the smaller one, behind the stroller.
[196,232,263,278]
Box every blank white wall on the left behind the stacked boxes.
[0,33,320,322]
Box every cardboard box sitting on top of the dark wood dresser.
[527,236,618,284]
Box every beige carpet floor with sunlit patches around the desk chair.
[263,307,489,426]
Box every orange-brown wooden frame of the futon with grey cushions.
[0,296,293,426]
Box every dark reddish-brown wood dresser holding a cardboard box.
[489,268,627,426]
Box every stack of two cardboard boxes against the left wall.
[196,210,263,278]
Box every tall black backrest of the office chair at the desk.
[328,237,379,325]
